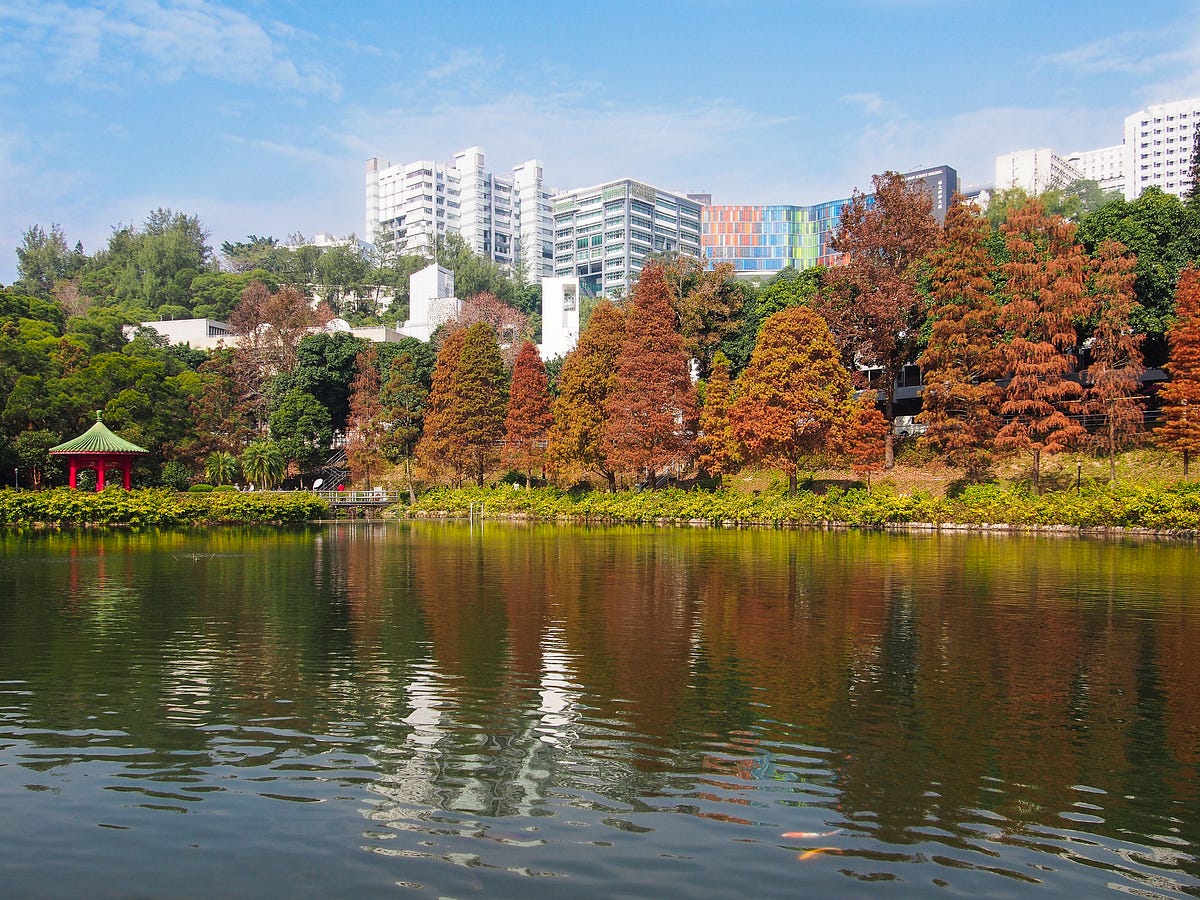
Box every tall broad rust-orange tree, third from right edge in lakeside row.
[996,199,1088,490]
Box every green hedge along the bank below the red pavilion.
[0,488,329,527]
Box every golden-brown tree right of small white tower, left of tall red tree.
[548,300,625,491]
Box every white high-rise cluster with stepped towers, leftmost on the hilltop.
[366,146,552,280]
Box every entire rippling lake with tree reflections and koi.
[0,522,1200,898]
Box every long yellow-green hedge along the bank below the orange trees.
[410,482,1200,532]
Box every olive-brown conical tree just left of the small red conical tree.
[451,322,509,486]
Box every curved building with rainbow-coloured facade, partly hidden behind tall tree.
[701,166,959,277]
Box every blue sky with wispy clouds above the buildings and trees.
[0,0,1200,283]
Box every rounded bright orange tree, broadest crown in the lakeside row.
[730,306,851,493]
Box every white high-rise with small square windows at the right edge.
[1124,97,1200,200]
